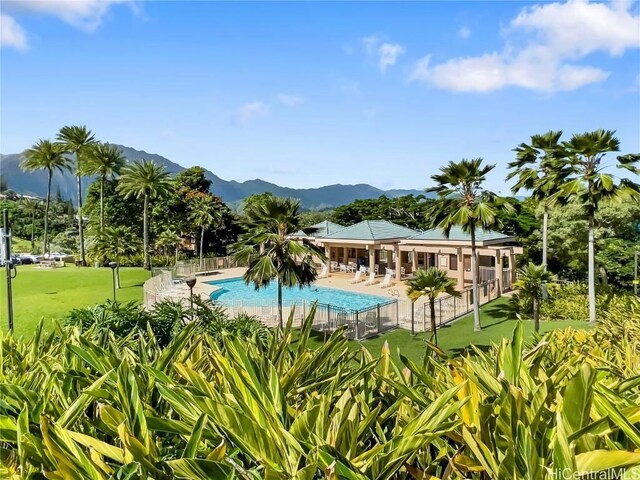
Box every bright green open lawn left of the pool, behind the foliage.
[0,264,149,336]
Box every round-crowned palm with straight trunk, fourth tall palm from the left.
[117,160,172,270]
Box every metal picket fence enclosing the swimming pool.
[143,267,499,340]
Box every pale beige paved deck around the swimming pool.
[193,267,410,303]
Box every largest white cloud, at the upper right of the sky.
[409,0,640,92]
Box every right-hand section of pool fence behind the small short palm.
[398,280,498,332]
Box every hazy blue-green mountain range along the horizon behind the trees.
[0,145,430,210]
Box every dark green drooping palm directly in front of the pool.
[233,195,326,328]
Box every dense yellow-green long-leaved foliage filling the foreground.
[0,305,640,480]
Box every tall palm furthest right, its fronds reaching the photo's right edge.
[554,129,640,325]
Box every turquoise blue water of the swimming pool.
[207,278,390,310]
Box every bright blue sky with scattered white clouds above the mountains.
[0,0,640,194]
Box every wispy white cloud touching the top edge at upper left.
[7,0,136,32]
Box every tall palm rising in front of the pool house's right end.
[426,158,513,331]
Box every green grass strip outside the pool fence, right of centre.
[300,298,589,362]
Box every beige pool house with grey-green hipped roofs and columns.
[295,220,522,290]
